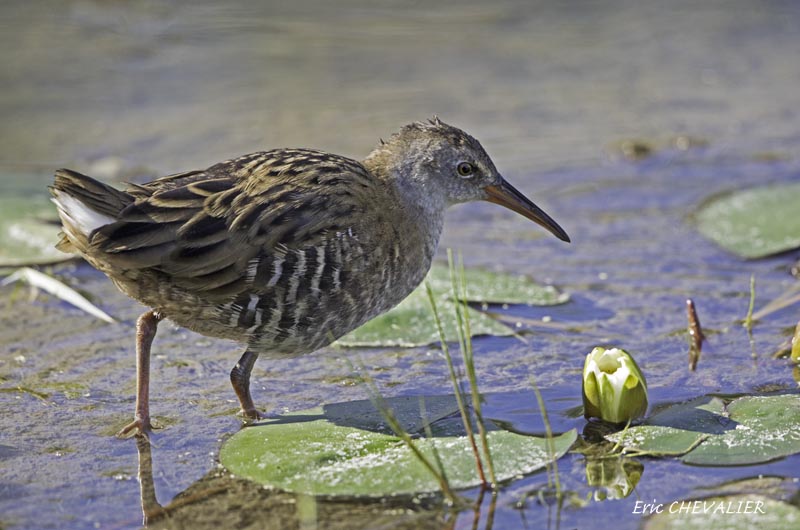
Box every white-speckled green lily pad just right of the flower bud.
[607,394,800,466]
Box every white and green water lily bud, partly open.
[583,347,647,423]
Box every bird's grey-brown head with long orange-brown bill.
[365,118,569,242]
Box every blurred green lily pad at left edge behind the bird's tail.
[0,195,73,267]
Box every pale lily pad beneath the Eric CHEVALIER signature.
[644,495,800,530]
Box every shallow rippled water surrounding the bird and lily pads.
[0,1,800,528]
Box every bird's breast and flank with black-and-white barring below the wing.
[238,208,441,355]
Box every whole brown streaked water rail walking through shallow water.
[50,118,569,436]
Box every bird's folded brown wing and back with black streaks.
[92,149,373,299]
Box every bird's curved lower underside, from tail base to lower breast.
[129,251,430,356]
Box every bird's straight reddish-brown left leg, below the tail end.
[117,311,163,438]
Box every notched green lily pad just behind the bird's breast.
[338,265,569,347]
